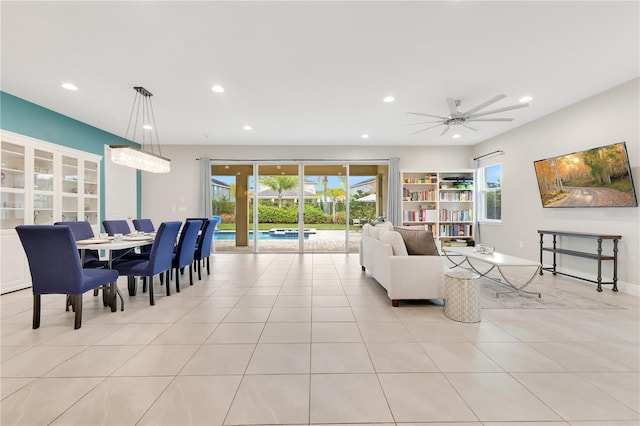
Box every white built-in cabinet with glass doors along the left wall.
[0,130,101,293]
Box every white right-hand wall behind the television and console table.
[474,79,640,295]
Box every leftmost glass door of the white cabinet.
[0,141,25,229]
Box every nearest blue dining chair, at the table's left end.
[16,225,118,329]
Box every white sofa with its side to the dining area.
[360,223,448,307]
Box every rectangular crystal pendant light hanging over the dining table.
[111,87,171,173]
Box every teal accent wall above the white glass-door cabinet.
[0,91,142,219]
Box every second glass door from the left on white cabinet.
[33,149,54,225]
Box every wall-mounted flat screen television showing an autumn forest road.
[533,142,638,208]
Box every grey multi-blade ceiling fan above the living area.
[407,95,529,136]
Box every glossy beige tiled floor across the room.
[0,254,640,426]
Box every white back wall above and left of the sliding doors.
[142,145,472,223]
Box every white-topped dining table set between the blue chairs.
[76,232,155,312]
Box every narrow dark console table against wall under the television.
[538,230,622,291]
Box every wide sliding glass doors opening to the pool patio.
[211,161,388,253]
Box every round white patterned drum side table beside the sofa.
[444,269,480,322]
